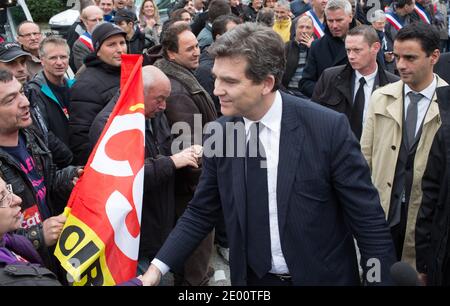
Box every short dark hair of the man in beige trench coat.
[394,22,440,56]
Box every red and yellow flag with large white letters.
[55,55,145,286]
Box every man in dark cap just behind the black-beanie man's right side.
[114,9,155,54]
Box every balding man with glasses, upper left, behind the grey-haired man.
[17,21,42,77]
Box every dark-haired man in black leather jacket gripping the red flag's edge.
[0,70,81,282]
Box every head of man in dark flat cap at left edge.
[0,42,31,84]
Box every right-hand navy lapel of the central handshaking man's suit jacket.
[277,94,304,236]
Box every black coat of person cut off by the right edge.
[416,86,450,286]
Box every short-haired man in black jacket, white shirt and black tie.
[311,25,399,139]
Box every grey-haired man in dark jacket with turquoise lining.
[27,36,74,145]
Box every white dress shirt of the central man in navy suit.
[152,91,289,275]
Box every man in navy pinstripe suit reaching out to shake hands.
[144,23,395,286]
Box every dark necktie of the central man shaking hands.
[246,122,272,278]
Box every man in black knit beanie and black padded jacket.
[69,22,127,165]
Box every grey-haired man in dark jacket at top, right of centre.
[298,0,356,97]
